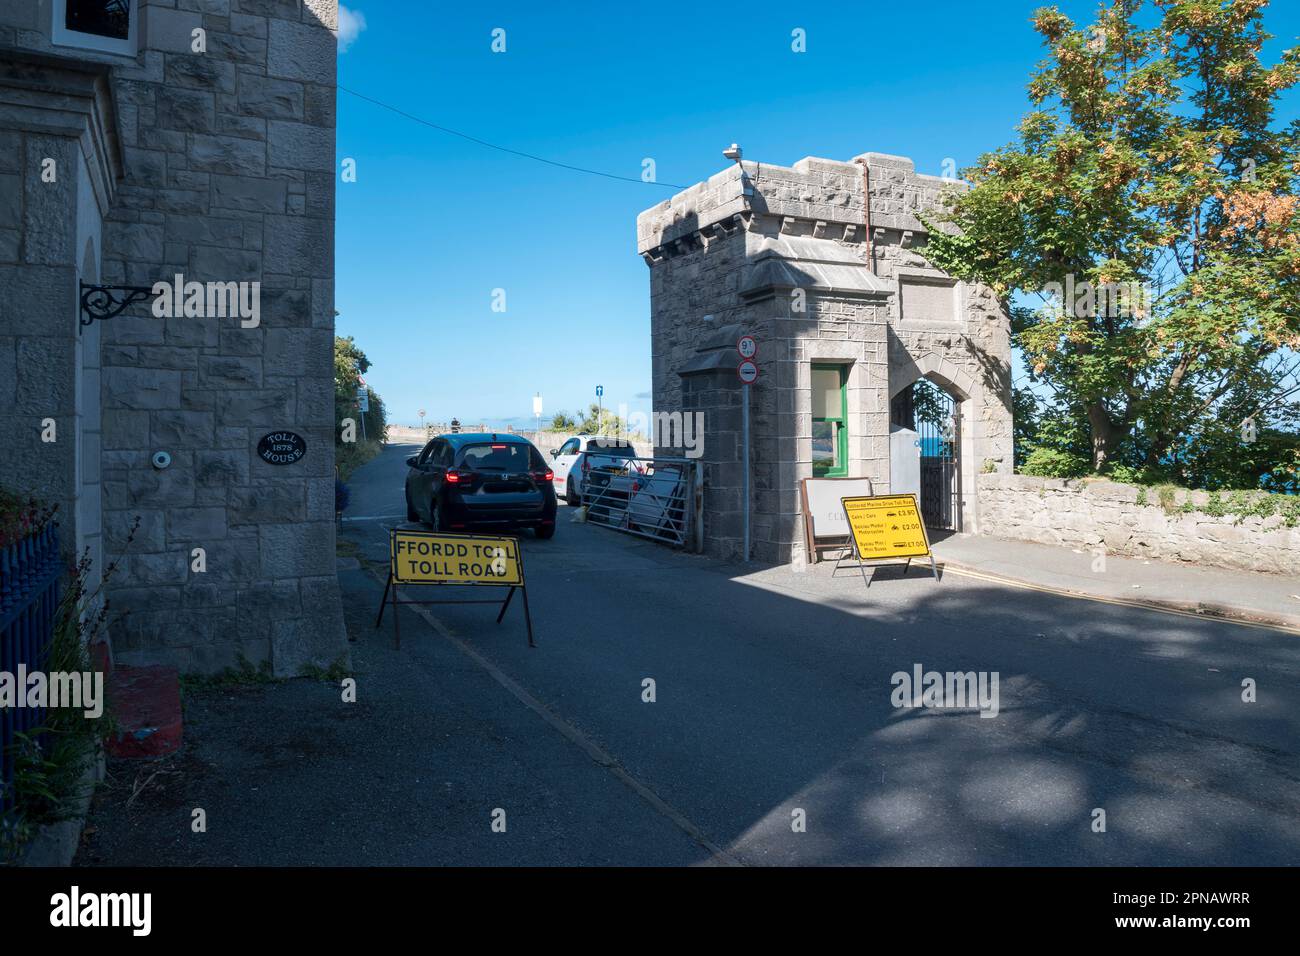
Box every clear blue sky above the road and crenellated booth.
[335,0,1300,427]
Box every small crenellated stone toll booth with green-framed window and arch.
[637,152,1013,563]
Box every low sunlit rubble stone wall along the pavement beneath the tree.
[979,475,1300,575]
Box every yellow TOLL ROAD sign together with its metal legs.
[374,528,537,649]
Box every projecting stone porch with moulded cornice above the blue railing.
[0,50,121,598]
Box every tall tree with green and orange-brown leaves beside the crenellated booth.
[926,0,1300,484]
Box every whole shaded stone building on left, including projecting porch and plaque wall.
[0,0,347,675]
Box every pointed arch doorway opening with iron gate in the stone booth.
[889,376,962,531]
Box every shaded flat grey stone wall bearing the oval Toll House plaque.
[0,0,347,675]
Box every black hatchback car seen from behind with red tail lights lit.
[406,433,555,537]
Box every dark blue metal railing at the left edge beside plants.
[0,525,62,814]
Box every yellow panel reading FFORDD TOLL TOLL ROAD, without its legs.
[389,529,524,585]
